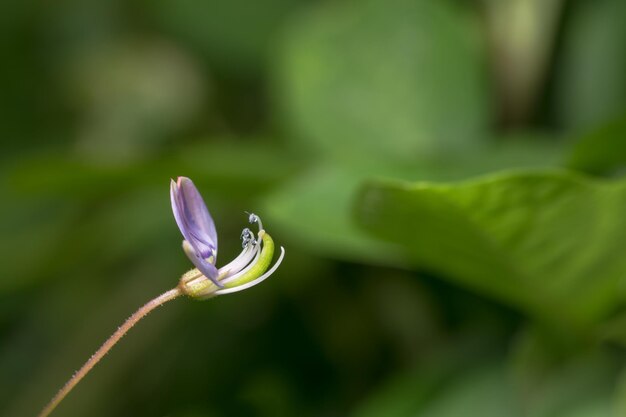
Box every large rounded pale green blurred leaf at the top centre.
[276,0,489,160]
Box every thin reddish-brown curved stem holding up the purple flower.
[38,288,182,417]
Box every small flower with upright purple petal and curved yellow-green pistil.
[170,177,285,299]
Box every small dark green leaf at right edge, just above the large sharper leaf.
[567,113,626,174]
